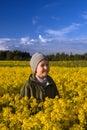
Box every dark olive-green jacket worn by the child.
[20,74,59,102]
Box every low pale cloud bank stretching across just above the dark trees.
[0,35,87,54]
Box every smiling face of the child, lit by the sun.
[36,60,50,79]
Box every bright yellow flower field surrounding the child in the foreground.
[0,66,87,130]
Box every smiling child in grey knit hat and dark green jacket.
[20,53,59,102]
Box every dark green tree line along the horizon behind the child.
[0,50,87,61]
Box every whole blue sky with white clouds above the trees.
[0,0,87,54]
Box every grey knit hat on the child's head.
[30,52,48,72]
